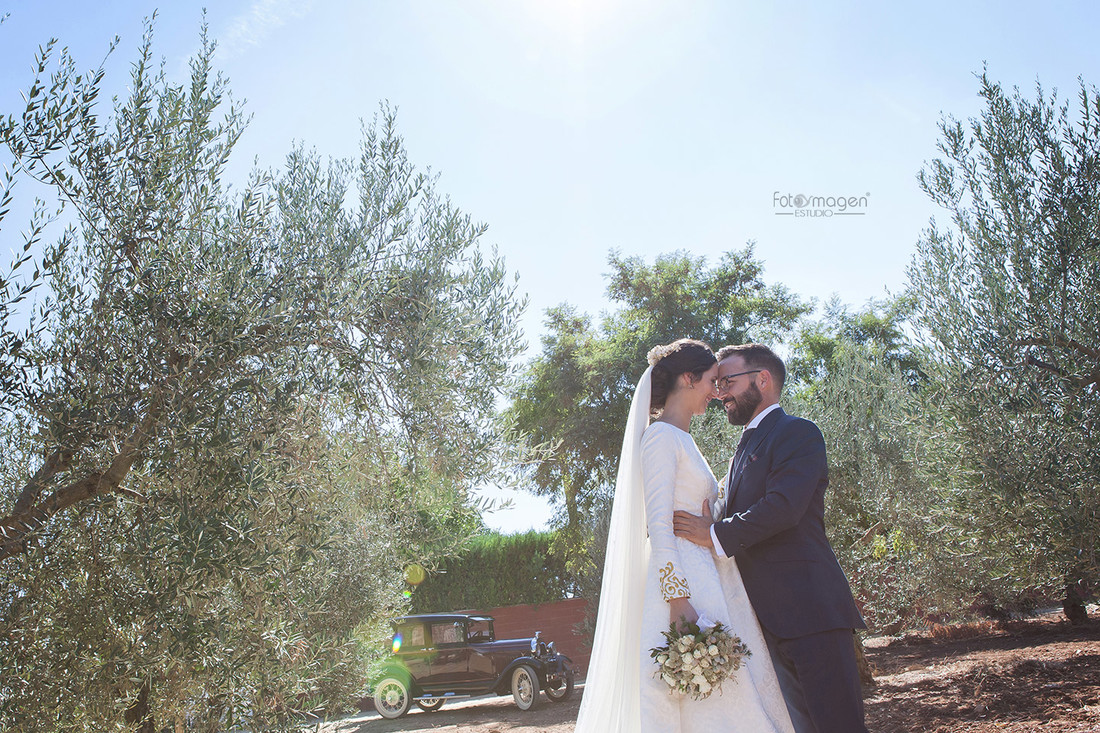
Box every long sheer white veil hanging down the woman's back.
[575,367,652,733]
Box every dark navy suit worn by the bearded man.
[713,408,866,733]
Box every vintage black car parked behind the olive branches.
[374,613,573,718]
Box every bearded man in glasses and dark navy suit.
[674,343,867,733]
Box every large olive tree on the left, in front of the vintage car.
[0,25,521,731]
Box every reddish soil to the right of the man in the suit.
[866,615,1100,733]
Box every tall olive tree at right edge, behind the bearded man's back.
[910,74,1100,620]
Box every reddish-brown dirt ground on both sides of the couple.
[317,609,1100,733]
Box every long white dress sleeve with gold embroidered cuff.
[641,423,691,601]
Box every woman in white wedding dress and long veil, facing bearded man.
[575,339,793,733]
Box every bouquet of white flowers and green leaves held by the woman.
[649,619,752,700]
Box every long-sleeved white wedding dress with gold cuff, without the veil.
[639,423,793,733]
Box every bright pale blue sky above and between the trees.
[0,0,1100,530]
